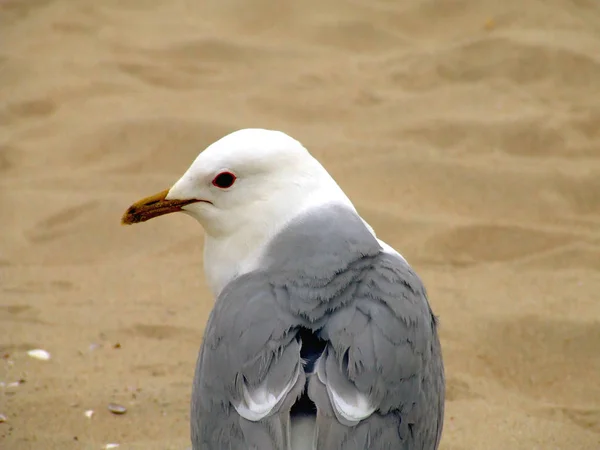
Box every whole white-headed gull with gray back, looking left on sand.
[121,128,445,450]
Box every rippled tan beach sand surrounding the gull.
[0,0,600,450]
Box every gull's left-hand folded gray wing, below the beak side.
[191,275,306,450]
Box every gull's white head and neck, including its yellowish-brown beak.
[122,129,353,295]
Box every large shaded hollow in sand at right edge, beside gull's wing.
[473,316,600,406]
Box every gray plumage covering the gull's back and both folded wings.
[191,206,445,450]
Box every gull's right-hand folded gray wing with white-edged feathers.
[309,253,445,450]
